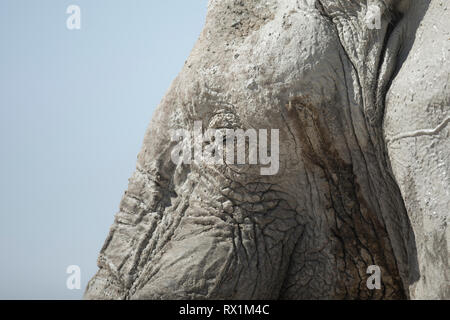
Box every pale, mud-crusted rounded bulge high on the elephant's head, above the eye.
[229,11,340,119]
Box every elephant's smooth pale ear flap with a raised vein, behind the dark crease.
[384,0,450,299]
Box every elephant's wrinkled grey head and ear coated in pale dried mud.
[85,0,450,299]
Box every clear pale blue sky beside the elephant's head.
[0,0,207,299]
